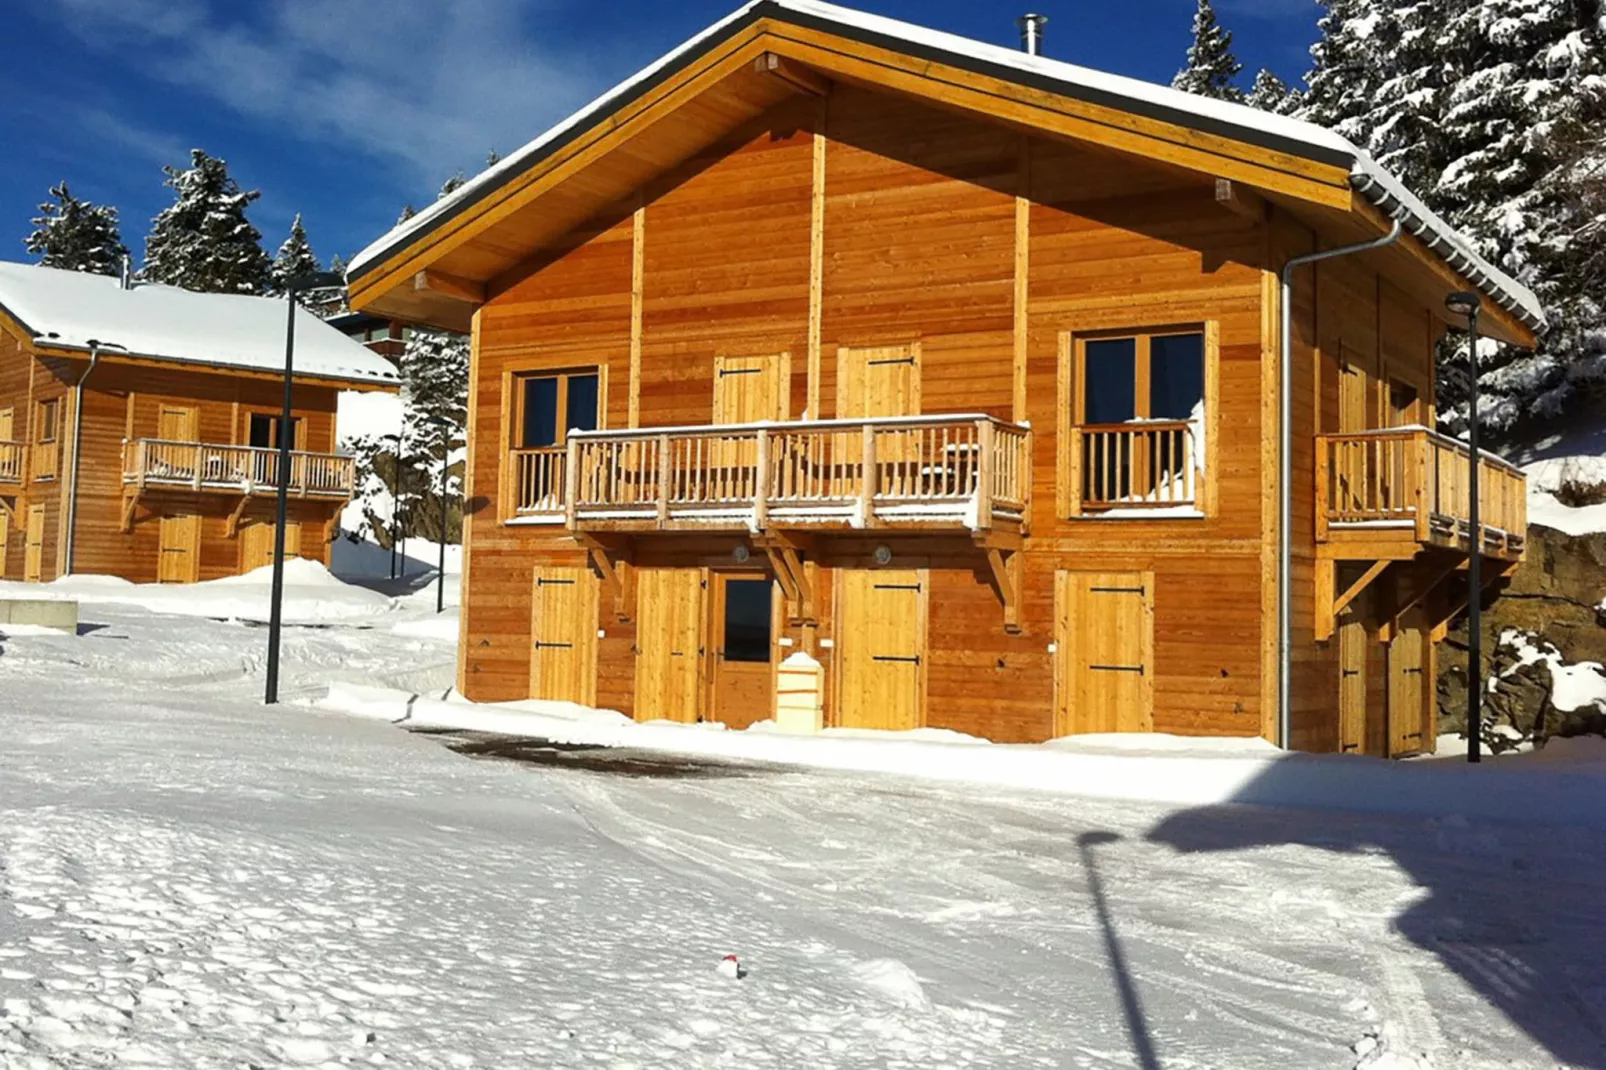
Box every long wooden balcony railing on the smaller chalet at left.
[122,439,355,498]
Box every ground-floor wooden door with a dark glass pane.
[708,572,776,729]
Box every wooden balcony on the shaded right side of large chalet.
[1315,427,1527,561]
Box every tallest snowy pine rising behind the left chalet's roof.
[141,149,268,294]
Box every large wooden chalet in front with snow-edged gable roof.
[350,0,1543,755]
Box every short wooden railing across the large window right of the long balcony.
[1071,419,1201,514]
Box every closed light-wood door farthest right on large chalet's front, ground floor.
[1055,570,1155,736]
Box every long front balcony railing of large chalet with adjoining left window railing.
[539,415,1031,530]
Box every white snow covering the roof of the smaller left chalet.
[0,262,400,382]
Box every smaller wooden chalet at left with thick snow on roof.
[0,263,400,583]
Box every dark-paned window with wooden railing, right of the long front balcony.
[1060,326,1211,516]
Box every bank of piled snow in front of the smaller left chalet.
[0,557,395,623]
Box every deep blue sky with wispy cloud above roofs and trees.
[0,0,1319,260]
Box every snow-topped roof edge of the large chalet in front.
[350,0,1545,329]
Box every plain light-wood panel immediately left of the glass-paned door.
[636,569,705,721]
